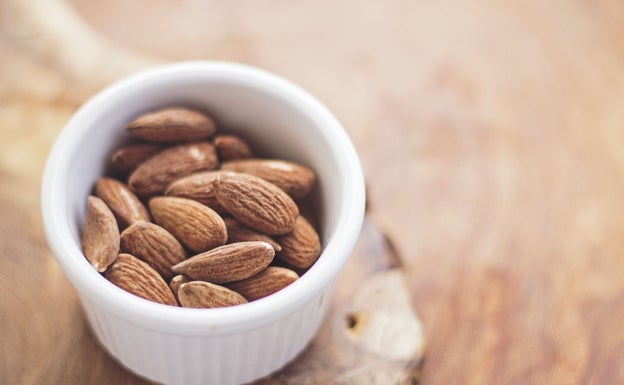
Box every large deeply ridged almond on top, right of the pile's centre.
[214,173,299,235]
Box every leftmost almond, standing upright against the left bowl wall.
[82,196,120,273]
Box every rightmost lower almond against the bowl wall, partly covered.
[278,216,321,269]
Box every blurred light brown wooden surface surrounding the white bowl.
[0,0,624,384]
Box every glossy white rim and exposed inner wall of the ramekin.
[42,63,364,332]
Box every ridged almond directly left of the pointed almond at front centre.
[121,221,186,279]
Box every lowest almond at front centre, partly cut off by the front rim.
[178,281,247,308]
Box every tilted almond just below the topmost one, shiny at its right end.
[128,142,218,197]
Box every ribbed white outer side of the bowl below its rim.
[81,288,329,385]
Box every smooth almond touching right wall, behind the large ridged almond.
[221,159,315,199]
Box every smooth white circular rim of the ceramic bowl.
[41,61,365,335]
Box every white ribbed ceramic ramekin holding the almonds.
[41,62,364,385]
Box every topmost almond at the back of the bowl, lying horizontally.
[126,108,216,143]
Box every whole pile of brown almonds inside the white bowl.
[82,108,321,308]
